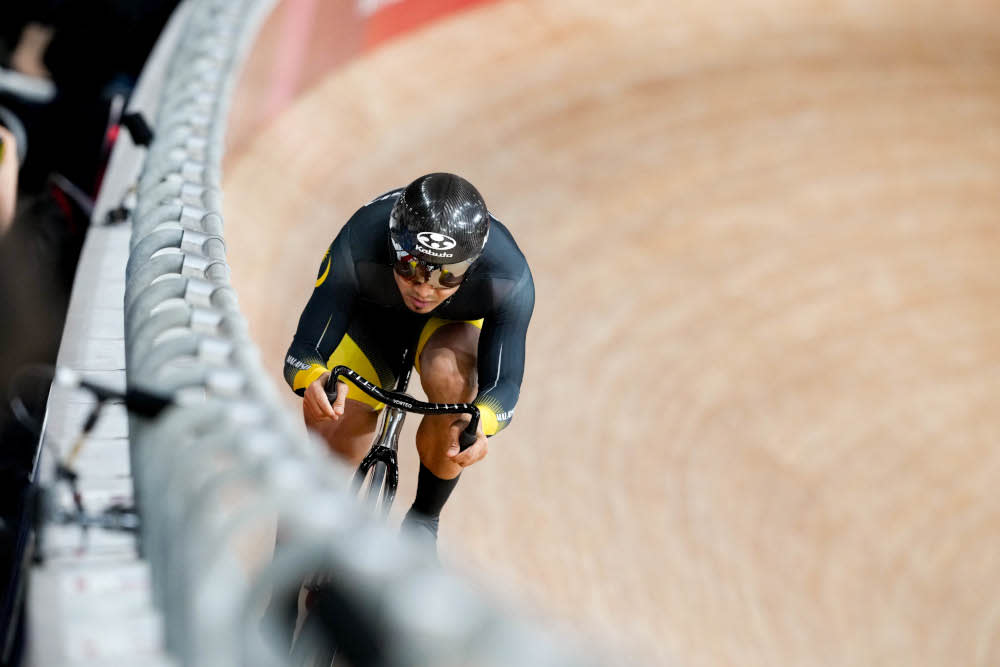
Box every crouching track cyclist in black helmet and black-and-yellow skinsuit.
[285,173,534,542]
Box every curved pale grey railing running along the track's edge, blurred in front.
[33,0,604,667]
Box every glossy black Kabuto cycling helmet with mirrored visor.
[389,173,490,288]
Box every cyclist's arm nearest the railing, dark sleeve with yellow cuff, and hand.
[284,226,358,419]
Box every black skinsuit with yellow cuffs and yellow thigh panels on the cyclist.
[285,189,535,435]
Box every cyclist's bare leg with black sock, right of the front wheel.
[403,322,479,539]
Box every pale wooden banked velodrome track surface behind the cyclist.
[225,0,1000,666]
